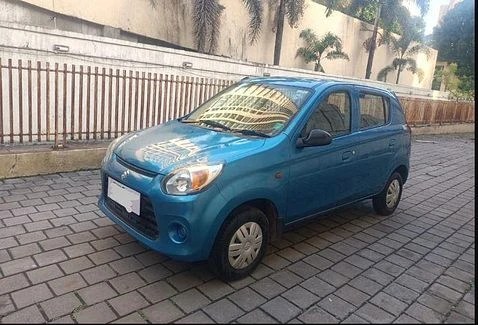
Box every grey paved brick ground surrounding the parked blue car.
[0,135,475,323]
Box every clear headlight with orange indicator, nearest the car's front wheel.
[163,163,224,195]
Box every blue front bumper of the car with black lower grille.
[98,155,226,261]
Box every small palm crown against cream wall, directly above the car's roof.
[296,28,349,72]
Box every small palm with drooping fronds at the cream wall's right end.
[377,26,430,84]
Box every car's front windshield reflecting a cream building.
[181,83,311,137]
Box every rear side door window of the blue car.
[359,93,390,129]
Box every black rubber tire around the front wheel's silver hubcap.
[209,207,269,281]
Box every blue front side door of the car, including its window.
[286,88,355,223]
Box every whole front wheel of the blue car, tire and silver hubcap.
[209,207,269,281]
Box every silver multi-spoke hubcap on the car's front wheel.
[229,222,262,269]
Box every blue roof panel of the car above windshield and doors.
[241,77,395,97]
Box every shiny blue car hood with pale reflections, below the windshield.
[115,121,265,175]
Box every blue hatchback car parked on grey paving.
[99,77,411,280]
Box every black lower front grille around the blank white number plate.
[103,176,159,239]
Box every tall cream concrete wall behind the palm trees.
[6,0,437,89]
